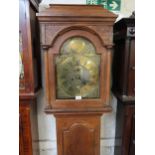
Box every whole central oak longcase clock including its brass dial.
[37,5,117,155]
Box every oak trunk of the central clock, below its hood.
[55,113,101,155]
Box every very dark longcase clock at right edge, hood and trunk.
[112,18,135,155]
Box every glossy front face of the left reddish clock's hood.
[19,0,29,94]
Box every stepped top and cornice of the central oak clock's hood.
[37,4,117,22]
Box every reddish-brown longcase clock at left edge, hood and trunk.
[19,0,41,155]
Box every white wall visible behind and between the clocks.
[37,0,134,155]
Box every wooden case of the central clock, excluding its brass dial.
[37,5,117,155]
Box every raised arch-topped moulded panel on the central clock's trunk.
[63,123,95,155]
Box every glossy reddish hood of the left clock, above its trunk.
[19,0,41,96]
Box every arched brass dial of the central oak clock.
[56,37,100,99]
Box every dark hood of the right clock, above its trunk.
[112,18,135,101]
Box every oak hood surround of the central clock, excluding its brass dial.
[37,5,117,110]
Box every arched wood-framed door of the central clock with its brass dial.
[45,26,110,109]
